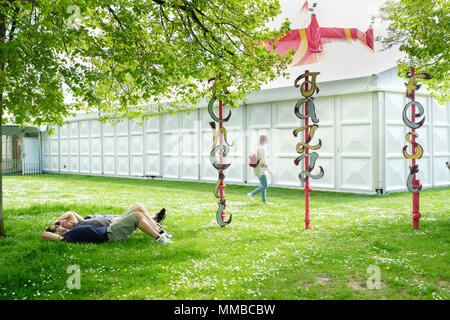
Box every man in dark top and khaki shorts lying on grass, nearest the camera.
[42,204,172,244]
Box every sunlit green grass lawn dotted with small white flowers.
[0,174,450,299]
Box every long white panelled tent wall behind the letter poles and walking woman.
[42,68,450,194]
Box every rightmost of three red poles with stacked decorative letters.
[402,67,431,229]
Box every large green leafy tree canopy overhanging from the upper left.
[0,0,290,235]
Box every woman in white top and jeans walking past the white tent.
[247,134,272,204]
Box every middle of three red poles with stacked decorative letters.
[294,70,324,229]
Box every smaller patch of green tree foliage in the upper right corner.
[378,0,450,103]
